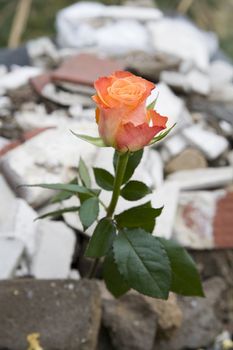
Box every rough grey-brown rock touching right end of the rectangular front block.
[103,294,157,350]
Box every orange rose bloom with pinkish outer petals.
[92,72,167,152]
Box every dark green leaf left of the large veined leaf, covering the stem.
[85,218,116,258]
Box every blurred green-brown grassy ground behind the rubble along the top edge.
[0,0,233,58]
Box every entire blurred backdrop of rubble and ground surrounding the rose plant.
[0,0,233,350]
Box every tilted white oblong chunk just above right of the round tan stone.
[183,125,228,160]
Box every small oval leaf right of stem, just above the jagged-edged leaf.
[121,180,152,201]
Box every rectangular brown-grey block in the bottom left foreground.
[0,280,101,350]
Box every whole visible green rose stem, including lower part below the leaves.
[87,152,129,278]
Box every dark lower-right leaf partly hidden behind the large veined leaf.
[156,237,204,297]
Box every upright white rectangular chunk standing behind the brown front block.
[31,221,76,279]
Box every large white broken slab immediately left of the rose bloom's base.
[1,122,96,207]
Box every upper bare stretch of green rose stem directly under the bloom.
[107,152,129,218]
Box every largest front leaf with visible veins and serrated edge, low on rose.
[113,229,171,299]
